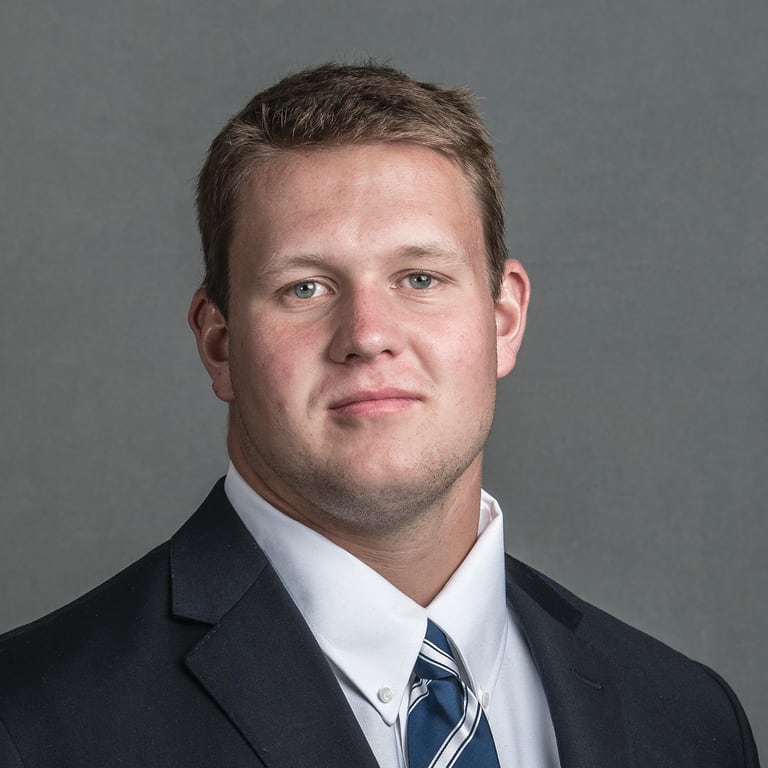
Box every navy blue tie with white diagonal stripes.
[406,621,499,768]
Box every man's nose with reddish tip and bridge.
[330,289,404,363]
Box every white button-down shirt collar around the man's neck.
[224,464,507,725]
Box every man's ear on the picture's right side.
[495,259,531,379]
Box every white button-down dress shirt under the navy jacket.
[224,464,560,768]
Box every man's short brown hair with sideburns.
[197,62,507,316]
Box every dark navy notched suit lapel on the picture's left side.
[171,483,376,768]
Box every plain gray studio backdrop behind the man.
[0,0,768,753]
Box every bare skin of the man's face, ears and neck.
[189,143,530,605]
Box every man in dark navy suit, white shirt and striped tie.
[0,65,758,768]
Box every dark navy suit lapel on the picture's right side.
[507,558,630,768]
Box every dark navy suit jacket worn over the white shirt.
[0,481,758,768]
